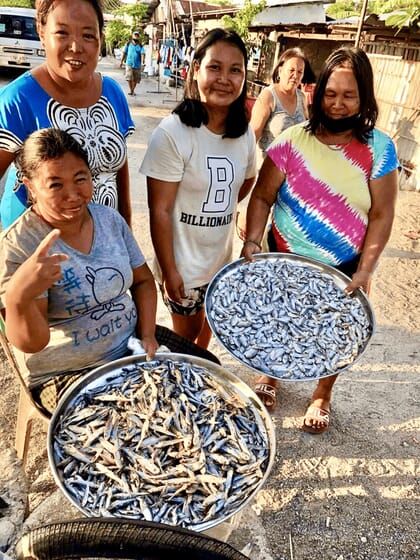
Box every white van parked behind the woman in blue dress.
[0,8,45,70]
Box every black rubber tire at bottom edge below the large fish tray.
[16,518,247,560]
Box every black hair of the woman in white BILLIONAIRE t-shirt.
[173,27,249,138]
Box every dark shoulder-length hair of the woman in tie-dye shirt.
[306,47,378,144]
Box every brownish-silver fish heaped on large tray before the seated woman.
[53,358,270,528]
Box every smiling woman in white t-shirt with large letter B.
[140,28,256,348]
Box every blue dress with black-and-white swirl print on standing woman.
[0,72,134,229]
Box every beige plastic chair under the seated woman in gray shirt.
[0,316,50,467]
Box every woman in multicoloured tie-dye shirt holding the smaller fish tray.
[242,48,398,433]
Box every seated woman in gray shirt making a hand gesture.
[0,129,158,413]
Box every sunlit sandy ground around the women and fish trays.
[0,61,420,560]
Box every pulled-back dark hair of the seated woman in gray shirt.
[16,128,89,179]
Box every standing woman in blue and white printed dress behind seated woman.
[0,0,134,228]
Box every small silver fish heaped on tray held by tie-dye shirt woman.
[206,258,372,380]
